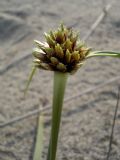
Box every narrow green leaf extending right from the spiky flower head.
[87,51,120,58]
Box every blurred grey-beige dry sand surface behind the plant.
[0,0,120,160]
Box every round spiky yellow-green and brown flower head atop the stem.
[33,24,91,73]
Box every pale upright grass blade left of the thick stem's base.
[33,115,44,160]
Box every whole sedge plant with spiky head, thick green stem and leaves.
[26,24,120,160]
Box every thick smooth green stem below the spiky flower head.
[47,72,68,160]
